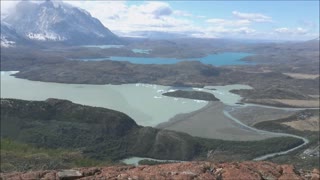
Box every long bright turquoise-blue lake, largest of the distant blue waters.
[73,52,253,66]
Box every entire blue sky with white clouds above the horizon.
[1,0,319,40]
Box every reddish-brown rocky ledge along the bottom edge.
[1,162,319,180]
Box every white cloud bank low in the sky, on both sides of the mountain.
[1,0,319,39]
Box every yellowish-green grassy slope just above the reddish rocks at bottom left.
[1,138,111,172]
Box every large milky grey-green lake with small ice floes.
[1,72,207,126]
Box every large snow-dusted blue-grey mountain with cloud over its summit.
[3,0,120,44]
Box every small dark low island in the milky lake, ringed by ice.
[162,90,219,101]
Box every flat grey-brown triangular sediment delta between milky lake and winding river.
[157,102,274,141]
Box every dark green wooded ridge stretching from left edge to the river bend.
[1,99,308,171]
